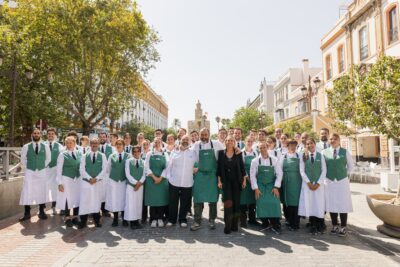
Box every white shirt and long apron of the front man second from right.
[299,151,326,218]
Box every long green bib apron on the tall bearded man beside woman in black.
[193,142,218,203]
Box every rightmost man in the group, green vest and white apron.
[322,133,353,237]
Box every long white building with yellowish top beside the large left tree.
[117,82,168,132]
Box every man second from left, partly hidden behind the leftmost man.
[45,128,64,215]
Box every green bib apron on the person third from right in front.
[281,153,302,206]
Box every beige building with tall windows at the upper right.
[318,0,400,164]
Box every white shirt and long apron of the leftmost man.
[19,141,51,205]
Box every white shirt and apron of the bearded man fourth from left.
[79,151,107,215]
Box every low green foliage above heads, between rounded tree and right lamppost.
[266,119,316,138]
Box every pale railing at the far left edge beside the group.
[0,147,25,180]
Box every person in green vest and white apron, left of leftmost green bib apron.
[124,145,146,230]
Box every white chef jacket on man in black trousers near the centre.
[166,149,197,188]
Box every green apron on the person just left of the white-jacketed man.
[144,152,169,207]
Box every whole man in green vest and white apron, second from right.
[299,139,326,235]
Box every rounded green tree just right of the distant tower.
[229,107,273,134]
